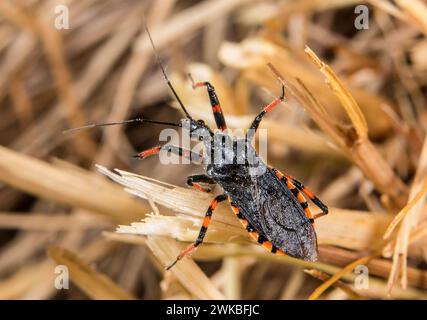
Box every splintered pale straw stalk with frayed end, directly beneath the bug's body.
[98,166,402,254]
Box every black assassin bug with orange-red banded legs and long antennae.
[66,28,328,269]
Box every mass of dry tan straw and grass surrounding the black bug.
[0,0,427,299]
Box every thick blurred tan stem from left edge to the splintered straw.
[0,147,149,221]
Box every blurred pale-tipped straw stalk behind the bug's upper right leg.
[218,34,391,135]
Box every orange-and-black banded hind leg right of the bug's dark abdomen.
[271,168,328,223]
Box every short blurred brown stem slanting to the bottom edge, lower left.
[48,246,136,300]
